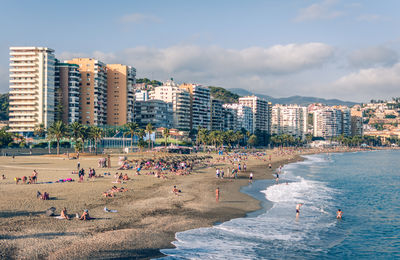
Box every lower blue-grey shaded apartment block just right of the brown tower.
[134,99,172,128]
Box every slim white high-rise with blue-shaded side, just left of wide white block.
[239,96,272,135]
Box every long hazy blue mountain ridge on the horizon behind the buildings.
[229,88,358,107]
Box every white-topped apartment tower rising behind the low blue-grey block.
[150,80,191,131]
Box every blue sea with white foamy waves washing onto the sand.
[161,151,400,259]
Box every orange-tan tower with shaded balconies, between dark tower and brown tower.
[66,58,107,126]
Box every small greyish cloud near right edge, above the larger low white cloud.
[348,46,399,68]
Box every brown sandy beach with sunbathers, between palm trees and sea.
[0,147,368,259]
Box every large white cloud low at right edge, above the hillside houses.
[333,63,400,100]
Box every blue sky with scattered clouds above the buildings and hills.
[0,0,400,102]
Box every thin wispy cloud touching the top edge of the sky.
[295,0,344,22]
